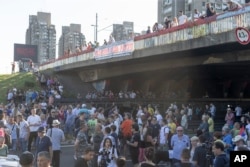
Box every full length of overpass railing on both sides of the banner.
[40,6,250,70]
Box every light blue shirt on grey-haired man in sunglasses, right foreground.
[171,134,190,160]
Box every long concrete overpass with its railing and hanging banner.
[40,6,250,99]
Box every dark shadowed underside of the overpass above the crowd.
[55,39,250,98]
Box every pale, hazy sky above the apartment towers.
[0,0,158,74]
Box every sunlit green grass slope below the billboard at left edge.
[0,73,40,104]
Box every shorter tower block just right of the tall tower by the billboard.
[58,24,86,57]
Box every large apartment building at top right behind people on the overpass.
[158,0,245,24]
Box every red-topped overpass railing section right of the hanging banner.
[134,6,250,50]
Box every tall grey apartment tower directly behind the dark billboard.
[26,12,56,63]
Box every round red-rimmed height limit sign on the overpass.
[235,27,250,45]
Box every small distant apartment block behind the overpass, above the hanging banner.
[112,21,134,41]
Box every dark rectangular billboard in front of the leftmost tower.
[14,44,38,63]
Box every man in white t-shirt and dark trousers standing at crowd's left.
[27,108,41,151]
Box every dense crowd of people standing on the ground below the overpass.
[0,85,250,167]
